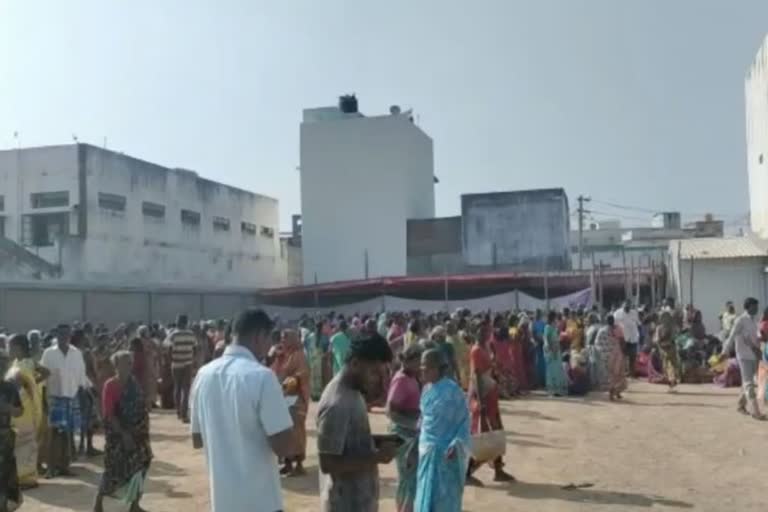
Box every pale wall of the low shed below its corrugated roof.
[668,256,768,334]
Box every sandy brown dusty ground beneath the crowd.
[23,383,768,512]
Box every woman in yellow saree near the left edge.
[8,334,50,489]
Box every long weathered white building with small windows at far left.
[0,144,286,288]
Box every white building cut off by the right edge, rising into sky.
[744,36,768,238]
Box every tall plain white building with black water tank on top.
[301,97,435,284]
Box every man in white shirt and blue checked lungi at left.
[40,324,92,478]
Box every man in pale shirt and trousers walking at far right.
[721,297,766,420]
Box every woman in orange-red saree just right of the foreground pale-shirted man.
[272,329,310,477]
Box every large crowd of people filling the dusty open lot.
[0,299,768,512]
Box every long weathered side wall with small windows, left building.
[80,146,285,286]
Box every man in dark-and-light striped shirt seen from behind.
[165,315,197,423]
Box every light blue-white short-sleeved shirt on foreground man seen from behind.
[189,345,293,512]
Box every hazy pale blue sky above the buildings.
[0,0,768,227]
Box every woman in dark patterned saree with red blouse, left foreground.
[93,350,152,512]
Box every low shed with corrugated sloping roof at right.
[667,237,768,334]
